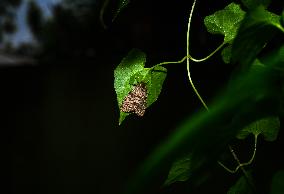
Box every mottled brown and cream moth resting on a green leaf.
[120,83,148,117]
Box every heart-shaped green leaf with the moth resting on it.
[114,49,167,124]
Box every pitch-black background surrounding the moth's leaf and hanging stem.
[0,0,283,194]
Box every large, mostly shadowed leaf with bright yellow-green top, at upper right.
[232,6,284,67]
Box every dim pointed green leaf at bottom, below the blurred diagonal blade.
[164,156,192,186]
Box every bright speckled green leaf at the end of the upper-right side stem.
[204,3,245,43]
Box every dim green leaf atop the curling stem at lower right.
[237,117,280,141]
